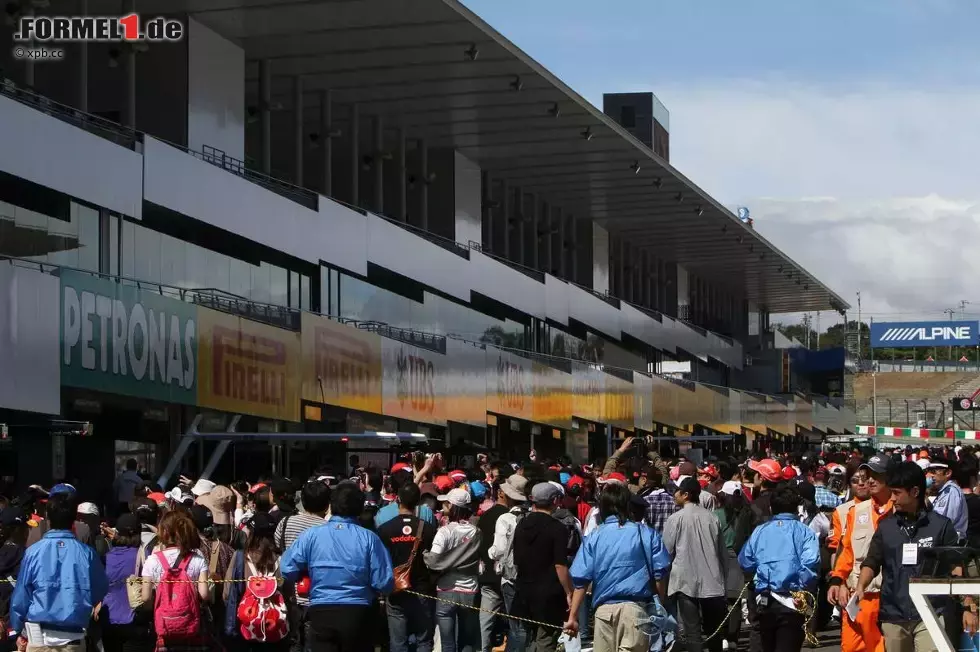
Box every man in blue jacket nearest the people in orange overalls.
[738,484,820,652]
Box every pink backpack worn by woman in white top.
[153,552,201,641]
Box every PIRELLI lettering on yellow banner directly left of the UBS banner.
[313,328,379,398]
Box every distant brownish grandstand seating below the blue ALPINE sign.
[854,371,980,428]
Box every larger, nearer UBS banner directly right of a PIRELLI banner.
[381,338,448,425]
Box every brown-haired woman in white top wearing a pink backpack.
[142,511,212,652]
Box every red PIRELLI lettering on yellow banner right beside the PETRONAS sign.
[211,326,286,406]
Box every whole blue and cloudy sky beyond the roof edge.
[463,0,980,327]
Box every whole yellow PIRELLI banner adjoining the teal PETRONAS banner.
[197,308,301,421]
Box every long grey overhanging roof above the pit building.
[107,0,850,313]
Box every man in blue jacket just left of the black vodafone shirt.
[280,481,395,652]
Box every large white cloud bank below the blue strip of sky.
[634,81,980,320]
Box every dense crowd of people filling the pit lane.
[0,438,980,652]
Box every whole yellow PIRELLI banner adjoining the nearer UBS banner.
[297,313,383,414]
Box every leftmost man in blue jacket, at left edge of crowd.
[10,493,109,652]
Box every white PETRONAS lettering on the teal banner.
[62,286,197,389]
